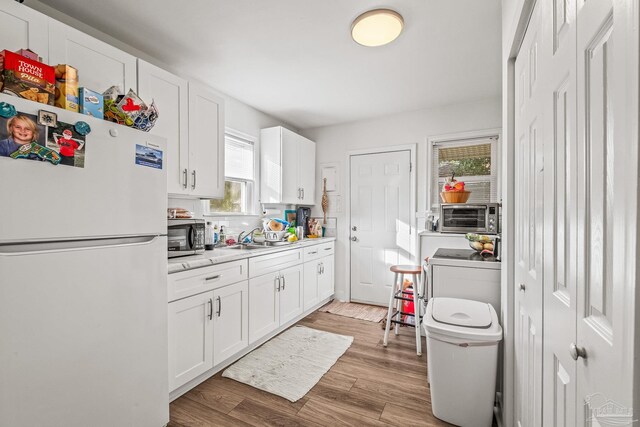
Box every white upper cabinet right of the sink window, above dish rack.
[260,126,316,205]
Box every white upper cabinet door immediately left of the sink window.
[188,82,224,199]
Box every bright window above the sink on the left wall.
[209,131,255,214]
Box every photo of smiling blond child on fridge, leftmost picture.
[0,112,61,165]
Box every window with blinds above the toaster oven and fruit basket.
[431,136,498,208]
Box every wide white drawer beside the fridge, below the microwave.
[169,259,249,301]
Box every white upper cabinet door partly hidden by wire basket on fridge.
[138,59,189,194]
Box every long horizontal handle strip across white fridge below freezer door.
[0,235,159,256]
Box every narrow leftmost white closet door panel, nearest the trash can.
[514,2,544,426]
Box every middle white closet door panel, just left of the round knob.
[540,0,578,427]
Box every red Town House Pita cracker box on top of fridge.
[0,50,55,105]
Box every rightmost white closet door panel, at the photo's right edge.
[577,0,638,425]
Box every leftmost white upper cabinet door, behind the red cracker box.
[0,0,49,64]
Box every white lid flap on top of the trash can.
[433,297,491,329]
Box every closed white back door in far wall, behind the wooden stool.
[350,150,412,305]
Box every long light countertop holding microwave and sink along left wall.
[168,237,336,274]
